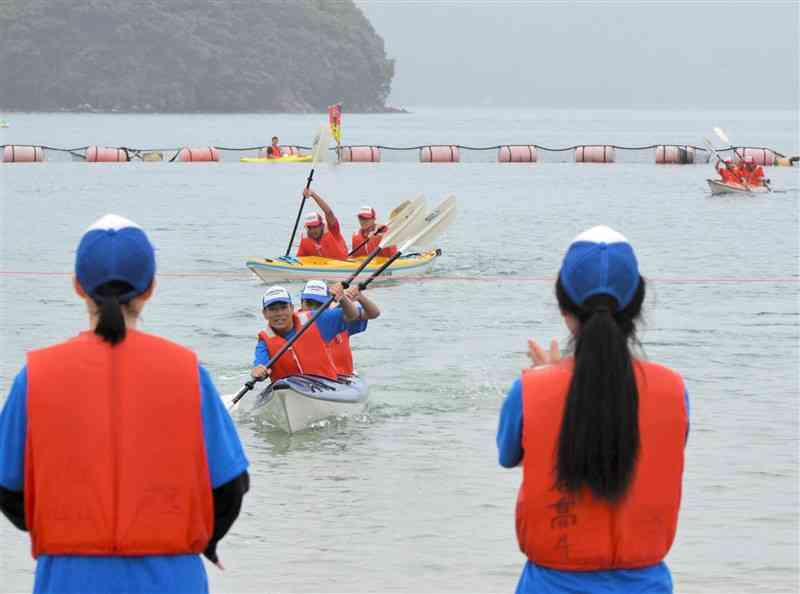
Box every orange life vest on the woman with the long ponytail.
[516,361,688,571]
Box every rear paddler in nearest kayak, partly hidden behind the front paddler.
[300,280,381,375]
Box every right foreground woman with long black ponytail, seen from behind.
[497,227,689,594]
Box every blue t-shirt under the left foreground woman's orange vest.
[0,366,248,594]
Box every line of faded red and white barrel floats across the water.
[0,144,800,166]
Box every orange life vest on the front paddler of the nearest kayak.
[258,311,337,381]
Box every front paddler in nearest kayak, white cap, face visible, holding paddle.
[250,283,359,381]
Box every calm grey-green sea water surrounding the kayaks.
[0,110,800,593]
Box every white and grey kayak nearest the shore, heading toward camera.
[250,375,369,433]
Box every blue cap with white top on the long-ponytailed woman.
[558,225,639,309]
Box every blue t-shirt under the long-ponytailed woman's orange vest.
[497,379,689,594]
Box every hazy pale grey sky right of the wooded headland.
[356,0,800,109]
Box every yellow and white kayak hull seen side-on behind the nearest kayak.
[247,250,441,283]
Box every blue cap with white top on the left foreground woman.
[75,214,156,303]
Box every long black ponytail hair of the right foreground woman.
[555,276,645,504]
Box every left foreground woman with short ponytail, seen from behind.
[0,215,249,593]
